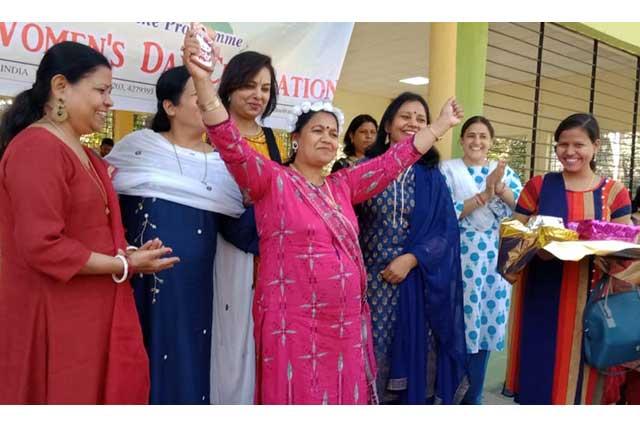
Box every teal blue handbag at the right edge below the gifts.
[582,275,640,370]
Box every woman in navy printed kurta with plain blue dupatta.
[359,93,466,404]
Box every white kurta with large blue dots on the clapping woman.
[443,162,522,353]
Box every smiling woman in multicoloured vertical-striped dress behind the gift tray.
[505,113,631,404]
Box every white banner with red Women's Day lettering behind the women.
[0,22,353,128]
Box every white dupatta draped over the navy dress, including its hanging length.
[106,129,255,404]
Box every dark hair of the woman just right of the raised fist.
[218,51,278,119]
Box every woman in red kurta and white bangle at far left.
[0,42,177,404]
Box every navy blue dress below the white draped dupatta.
[120,195,218,404]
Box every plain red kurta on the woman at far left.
[0,127,148,404]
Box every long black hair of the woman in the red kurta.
[0,42,111,158]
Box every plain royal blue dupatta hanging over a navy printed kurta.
[390,164,468,404]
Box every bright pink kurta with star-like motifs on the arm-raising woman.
[208,121,420,404]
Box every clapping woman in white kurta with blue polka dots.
[441,116,522,404]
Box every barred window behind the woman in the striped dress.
[484,23,640,196]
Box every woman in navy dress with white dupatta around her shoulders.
[106,67,252,404]
